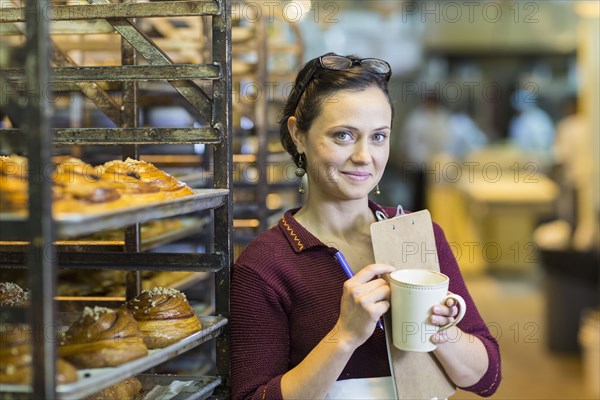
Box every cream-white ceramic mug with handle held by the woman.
[390,269,467,352]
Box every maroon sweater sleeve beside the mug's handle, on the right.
[434,224,502,397]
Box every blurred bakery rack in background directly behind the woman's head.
[232,0,304,255]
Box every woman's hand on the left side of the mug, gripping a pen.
[335,264,395,347]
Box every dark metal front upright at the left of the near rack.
[21,0,56,399]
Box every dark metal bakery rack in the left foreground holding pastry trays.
[0,0,232,400]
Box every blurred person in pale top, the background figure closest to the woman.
[400,92,450,211]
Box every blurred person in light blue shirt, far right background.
[508,89,554,168]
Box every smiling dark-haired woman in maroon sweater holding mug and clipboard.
[231,53,500,399]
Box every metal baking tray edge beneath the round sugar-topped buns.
[0,316,227,400]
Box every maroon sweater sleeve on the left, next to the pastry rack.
[230,264,289,400]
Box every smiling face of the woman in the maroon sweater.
[288,87,392,200]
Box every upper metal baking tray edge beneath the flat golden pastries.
[0,189,229,238]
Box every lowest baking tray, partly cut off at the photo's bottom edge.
[133,375,221,400]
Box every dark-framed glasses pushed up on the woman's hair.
[294,55,392,109]
